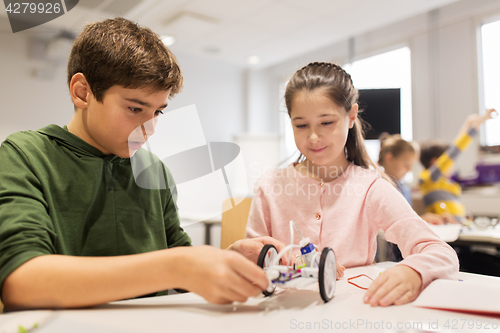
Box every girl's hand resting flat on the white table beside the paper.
[363,265,422,306]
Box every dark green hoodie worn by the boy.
[0,125,191,295]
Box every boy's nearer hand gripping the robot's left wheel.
[179,246,269,304]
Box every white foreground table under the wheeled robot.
[0,263,500,333]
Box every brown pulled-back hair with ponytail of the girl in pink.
[285,62,385,172]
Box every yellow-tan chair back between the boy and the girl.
[220,198,252,249]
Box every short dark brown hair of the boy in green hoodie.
[68,18,183,102]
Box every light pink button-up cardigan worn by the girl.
[246,164,458,288]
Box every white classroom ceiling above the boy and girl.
[0,0,457,68]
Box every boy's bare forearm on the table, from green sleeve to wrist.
[2,248,189,310]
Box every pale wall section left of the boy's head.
[0,32,73,141]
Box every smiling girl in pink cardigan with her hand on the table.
[247,62,458,306]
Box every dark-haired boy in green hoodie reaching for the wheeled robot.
[0,18,283,310]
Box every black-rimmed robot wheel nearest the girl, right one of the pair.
[318,247,337,303]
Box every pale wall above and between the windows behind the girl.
[254,0,500,173]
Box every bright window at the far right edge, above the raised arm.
[479,21,500,146]
